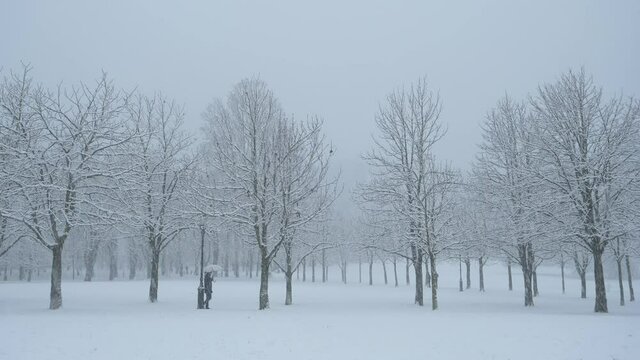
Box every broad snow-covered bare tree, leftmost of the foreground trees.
[3,69,128,309]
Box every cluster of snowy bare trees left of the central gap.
[0,66,337,309]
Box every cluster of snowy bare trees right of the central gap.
[357,70,640,312]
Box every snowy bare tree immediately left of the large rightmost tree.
[472,96,538,306]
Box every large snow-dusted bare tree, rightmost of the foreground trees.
[531,70,640,312]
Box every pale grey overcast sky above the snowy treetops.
[0,0,640,190]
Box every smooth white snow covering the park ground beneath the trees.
[0,264,640,360]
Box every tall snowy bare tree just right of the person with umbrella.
[203,78,285,310]
